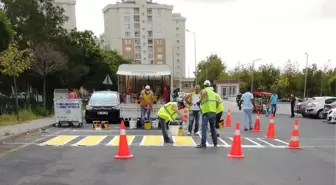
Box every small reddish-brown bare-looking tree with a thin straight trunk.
[31,43,68,108]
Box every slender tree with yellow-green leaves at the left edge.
[0,37,32,120]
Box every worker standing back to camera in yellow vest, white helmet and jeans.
[197,80,219,148]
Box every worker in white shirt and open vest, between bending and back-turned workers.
[186,85,201,135]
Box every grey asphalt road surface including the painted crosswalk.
[0,110,336,185]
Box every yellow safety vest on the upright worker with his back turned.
[201,87,217,114]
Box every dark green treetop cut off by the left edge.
[0,10,14,53]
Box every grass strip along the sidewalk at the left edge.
[0,107,50,127]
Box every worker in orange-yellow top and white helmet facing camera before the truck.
[140,85,153,128]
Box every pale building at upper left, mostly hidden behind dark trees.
[54,0,76,30]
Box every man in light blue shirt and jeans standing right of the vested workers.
[241,87,255,131]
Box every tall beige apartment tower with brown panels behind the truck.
[102,0,186,77]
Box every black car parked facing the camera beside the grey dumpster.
[85,91,120,124]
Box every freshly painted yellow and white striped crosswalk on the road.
[37,135,288,148]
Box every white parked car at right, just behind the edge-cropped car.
[305,96,336,119]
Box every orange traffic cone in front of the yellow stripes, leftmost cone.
[114,120,133,159]
